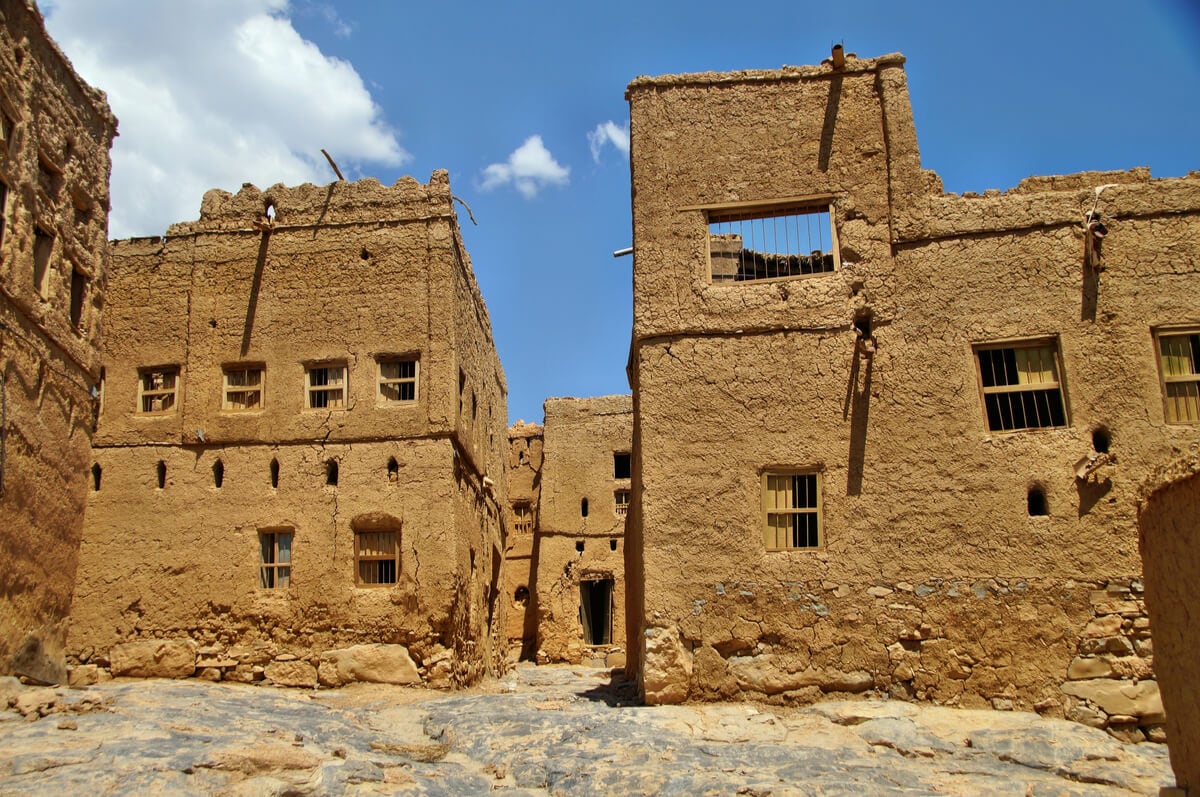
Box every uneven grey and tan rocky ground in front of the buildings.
[0,666,1174,797]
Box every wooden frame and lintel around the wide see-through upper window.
[696,194,841,284]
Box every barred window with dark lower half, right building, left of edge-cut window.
[976,342,1067,432]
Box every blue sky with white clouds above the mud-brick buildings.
[41,0,1200,423]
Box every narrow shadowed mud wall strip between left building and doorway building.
[504,420,544,660]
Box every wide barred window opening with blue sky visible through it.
[708,200,838,282]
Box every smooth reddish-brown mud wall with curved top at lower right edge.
[1138,445,1200,791]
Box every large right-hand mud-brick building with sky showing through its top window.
[624,50,1200,738]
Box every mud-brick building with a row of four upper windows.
[70,172,508,685]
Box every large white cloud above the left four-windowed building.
[43,0,409,238]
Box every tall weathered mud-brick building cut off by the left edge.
[0,0,116,683]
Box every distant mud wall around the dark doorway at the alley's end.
[535,396,634,666]
